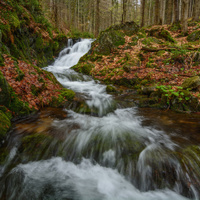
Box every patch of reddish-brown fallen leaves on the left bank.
[0,55,61,109]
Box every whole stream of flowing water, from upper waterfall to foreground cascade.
[0,39,200,200]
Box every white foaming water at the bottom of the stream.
[9,158,187,200]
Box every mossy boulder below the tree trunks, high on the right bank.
[148,28,175,43]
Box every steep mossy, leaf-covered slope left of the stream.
[0,0,74,139]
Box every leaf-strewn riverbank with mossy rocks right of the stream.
[73,22,200,112]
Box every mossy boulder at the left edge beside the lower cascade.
[0,110,11,141]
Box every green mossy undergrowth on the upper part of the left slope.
[0,0,67,67]
